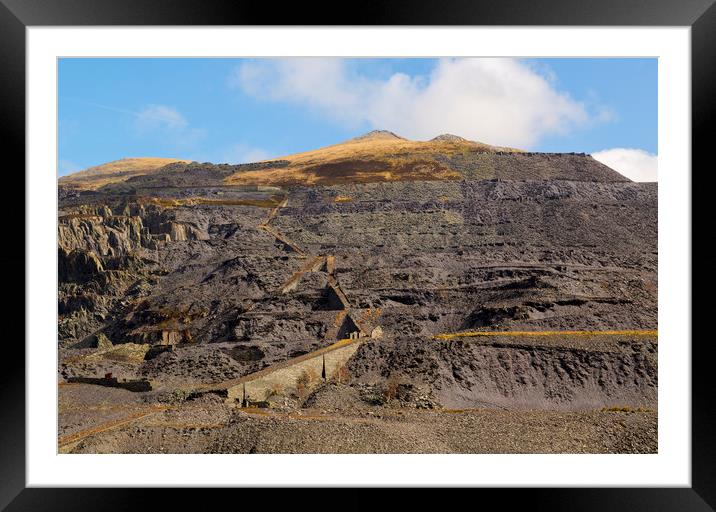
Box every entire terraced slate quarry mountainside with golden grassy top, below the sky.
[58,131,658,453]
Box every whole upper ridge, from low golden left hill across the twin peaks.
[60,130,629,192]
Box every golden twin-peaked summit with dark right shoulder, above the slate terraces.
[224,131,628,186]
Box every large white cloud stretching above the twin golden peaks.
[231,58,602,148]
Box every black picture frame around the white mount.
[0,0,716,511]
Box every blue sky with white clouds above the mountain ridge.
[58,59,657,179]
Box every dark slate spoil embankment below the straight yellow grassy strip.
[349,333,657,410]
